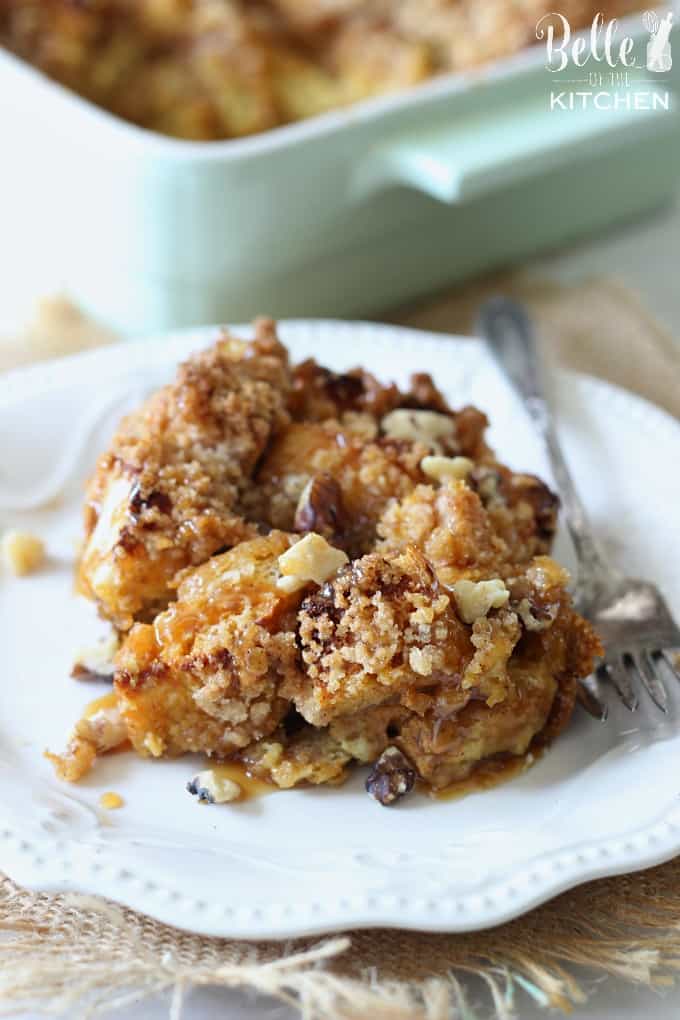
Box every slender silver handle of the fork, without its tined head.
[477,297,614,591]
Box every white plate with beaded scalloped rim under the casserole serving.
[0,321,680,937]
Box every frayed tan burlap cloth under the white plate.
[0,276,680,1020]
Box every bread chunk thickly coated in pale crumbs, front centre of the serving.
[284,548,471,726]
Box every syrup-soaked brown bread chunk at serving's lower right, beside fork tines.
[330,605,601,789]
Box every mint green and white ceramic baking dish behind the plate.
[0,15,680,332]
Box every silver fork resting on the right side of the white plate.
[477,297,680,719]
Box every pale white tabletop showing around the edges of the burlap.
[9,203,680,1020]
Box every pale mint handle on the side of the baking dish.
[352,83,678,204]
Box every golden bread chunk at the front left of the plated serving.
[115,531,304,757]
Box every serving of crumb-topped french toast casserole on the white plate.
[50,319,601,804]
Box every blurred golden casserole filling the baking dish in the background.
[0,0,642,141]
